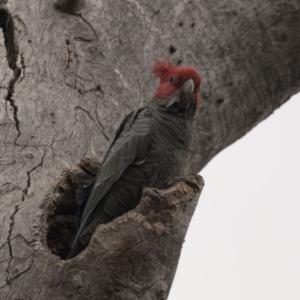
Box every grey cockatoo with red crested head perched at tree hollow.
[66,59,201,259]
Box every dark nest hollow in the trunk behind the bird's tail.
[47,159,99,259]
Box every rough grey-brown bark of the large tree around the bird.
[0,0,300,299]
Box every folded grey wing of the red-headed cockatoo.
[73,107,152,245]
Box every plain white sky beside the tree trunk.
[168,93,300,300]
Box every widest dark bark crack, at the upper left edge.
[0,7,21,142]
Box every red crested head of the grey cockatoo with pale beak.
[153,60,201,109]
